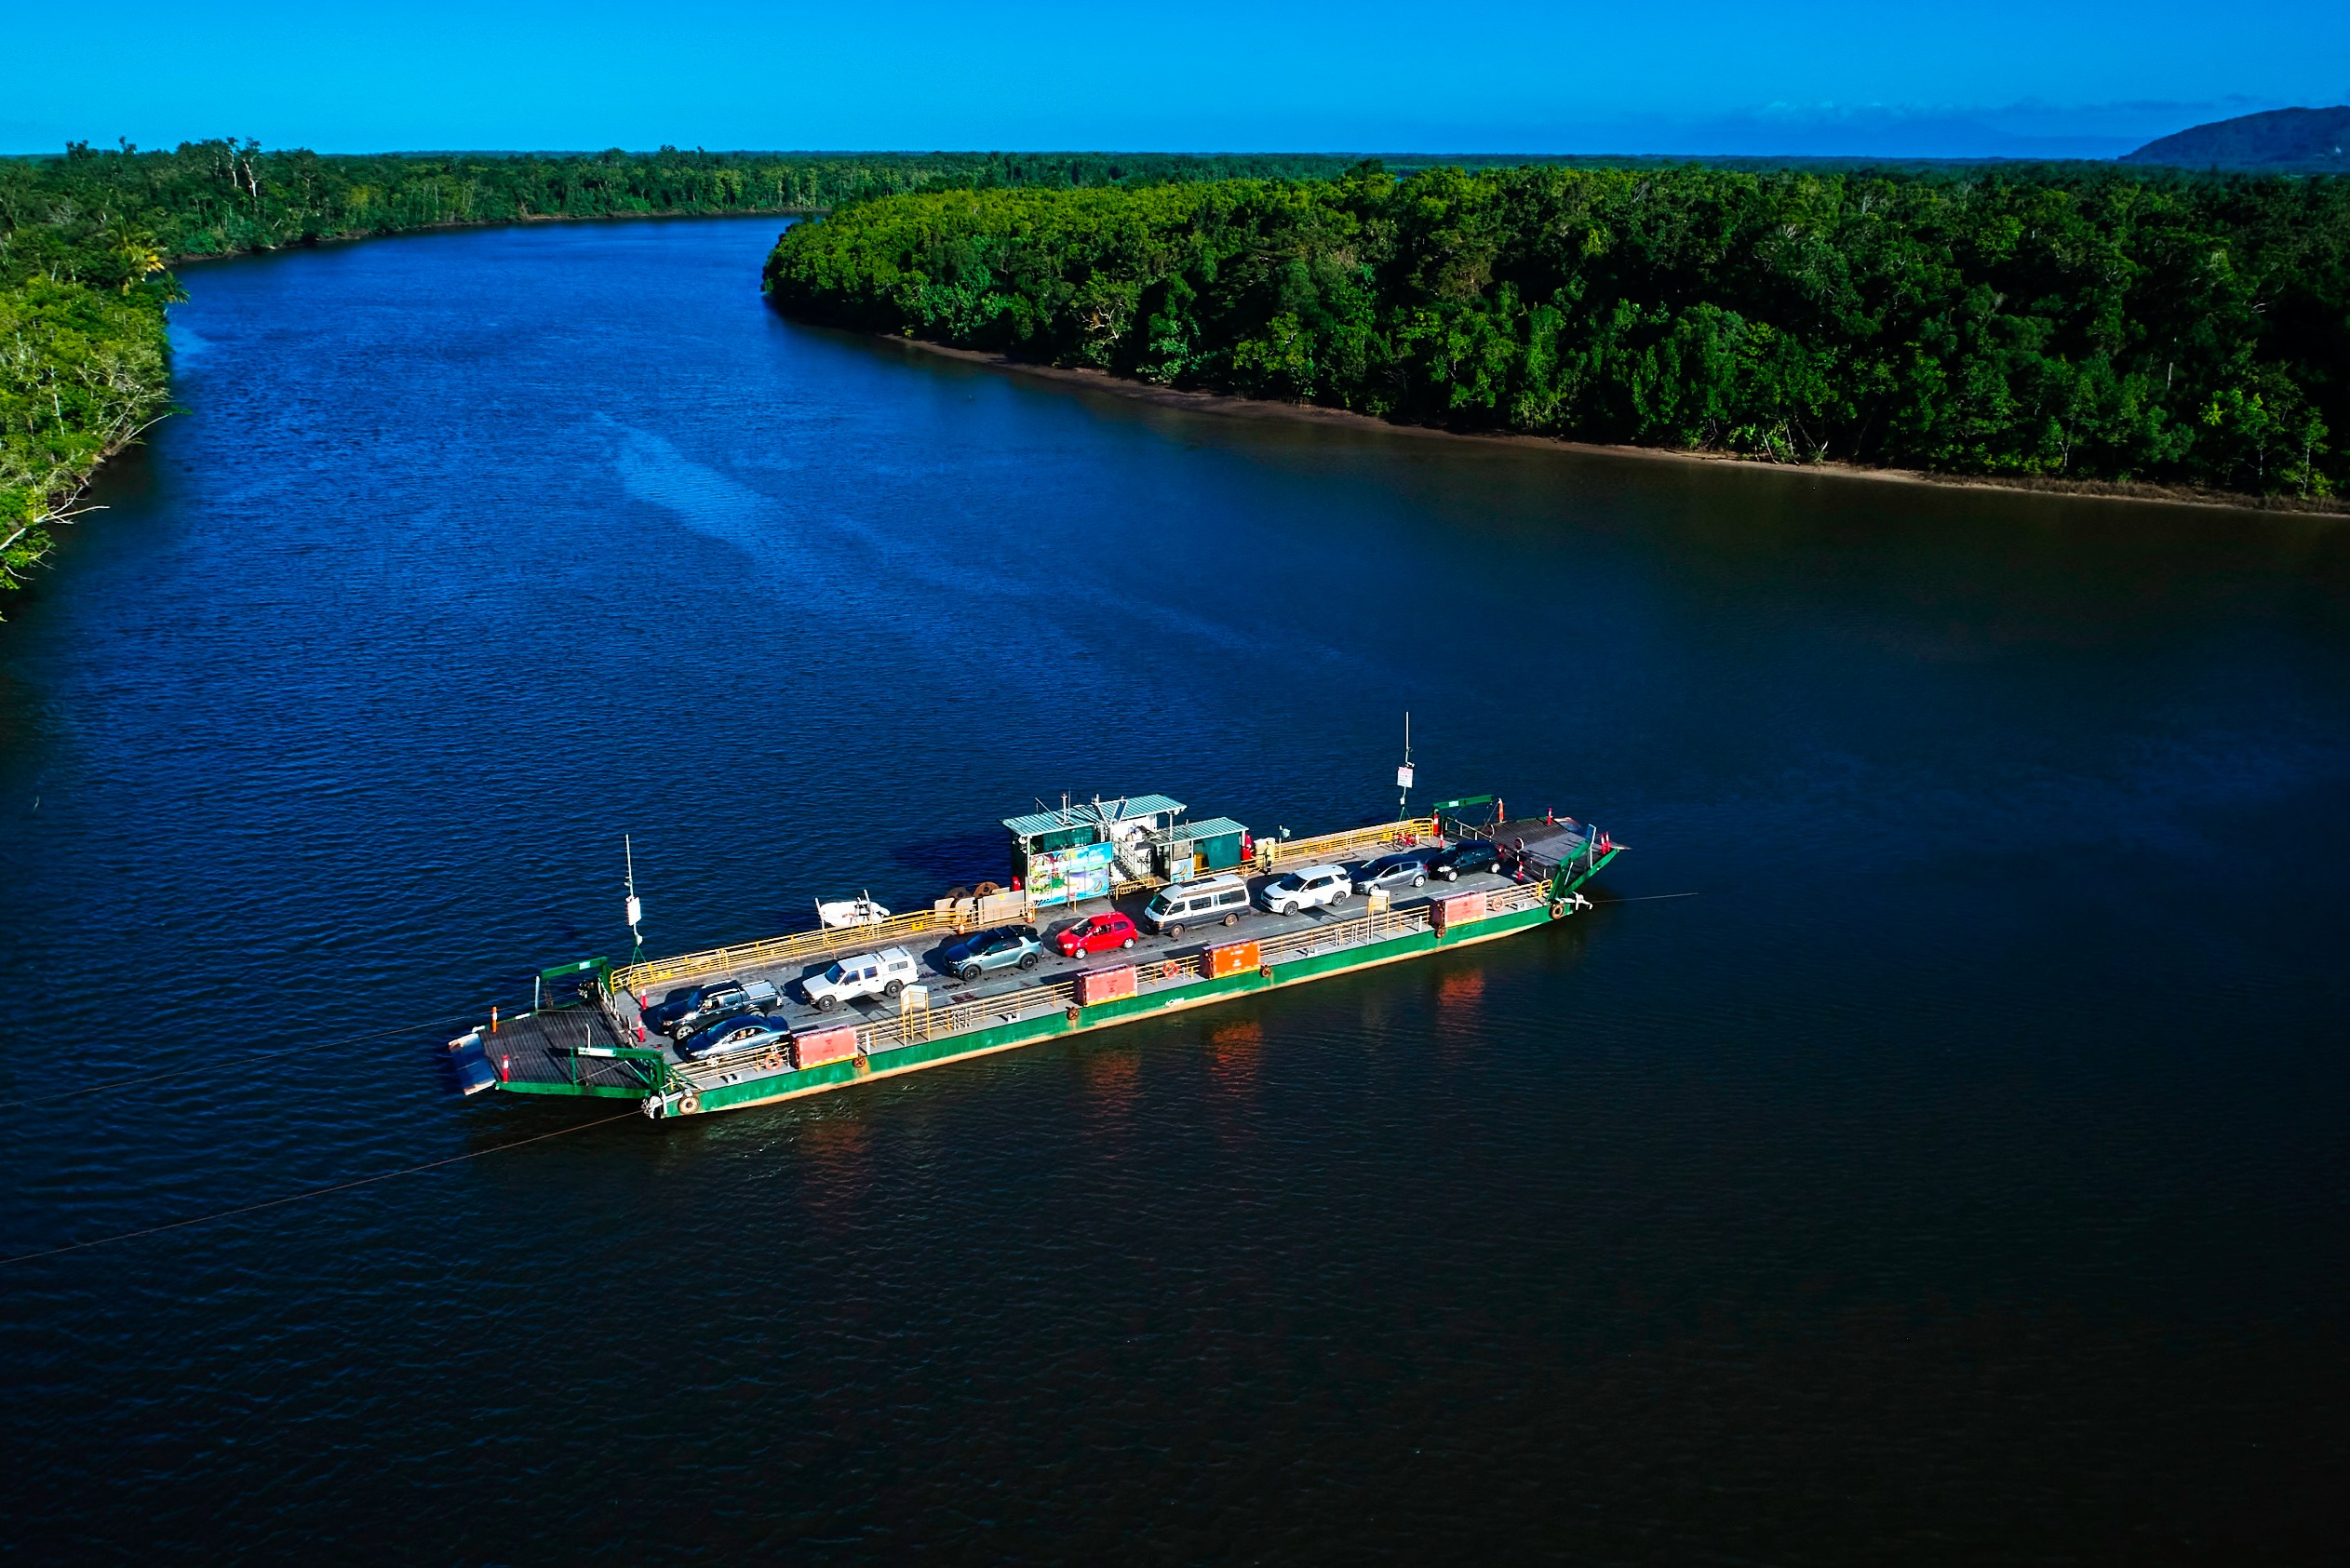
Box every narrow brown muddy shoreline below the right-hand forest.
[874,331,2350,517]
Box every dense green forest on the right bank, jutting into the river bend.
[766,165,2350,499]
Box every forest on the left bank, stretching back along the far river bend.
[0,139,1344,606]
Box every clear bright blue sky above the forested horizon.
[0,0,2350,157]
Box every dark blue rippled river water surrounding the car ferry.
[0,223,2350,1563]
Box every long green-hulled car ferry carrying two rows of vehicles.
[449,795,1621,1121]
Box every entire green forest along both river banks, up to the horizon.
[0,150,2350,610]
